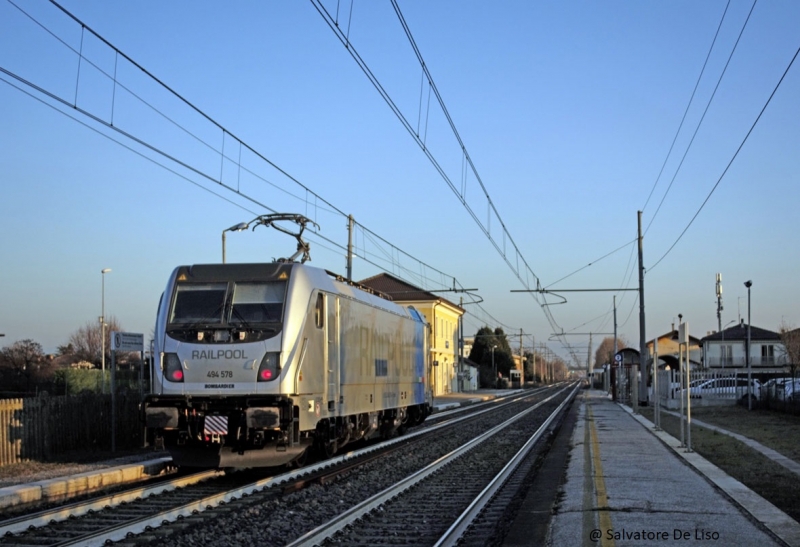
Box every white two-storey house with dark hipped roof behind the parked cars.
[701,320,789,369]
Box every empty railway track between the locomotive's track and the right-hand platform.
[289,388,575,547]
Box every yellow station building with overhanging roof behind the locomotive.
[358,273,464,396]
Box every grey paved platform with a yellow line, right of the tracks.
[544,390,800,547]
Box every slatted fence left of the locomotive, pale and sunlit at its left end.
[0,393,144,466]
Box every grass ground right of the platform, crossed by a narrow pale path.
[641,407,800,521]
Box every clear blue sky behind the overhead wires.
[0,0,800,368]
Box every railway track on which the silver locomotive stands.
[0,392,576,546]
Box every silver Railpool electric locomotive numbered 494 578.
[142,261,432,467]
